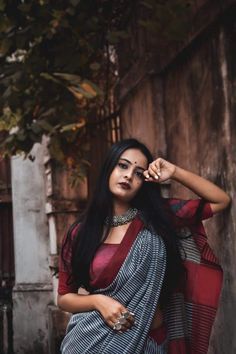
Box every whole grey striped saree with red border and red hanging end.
[59,199,223,354]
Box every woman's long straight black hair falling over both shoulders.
[62,139,185,304]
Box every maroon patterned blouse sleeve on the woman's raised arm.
[168,198,213,226]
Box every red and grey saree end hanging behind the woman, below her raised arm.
[165,199,223,354]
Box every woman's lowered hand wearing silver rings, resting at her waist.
[96,294,134,332]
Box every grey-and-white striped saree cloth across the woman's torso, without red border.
[61,229,167,354]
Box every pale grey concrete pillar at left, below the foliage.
[12,144,52,354]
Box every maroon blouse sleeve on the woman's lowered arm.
[58,225,79,295]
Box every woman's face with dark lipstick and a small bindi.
[109,149,148,203]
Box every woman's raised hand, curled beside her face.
[143,157,176,182]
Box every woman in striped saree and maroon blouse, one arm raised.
[58,139,230,354]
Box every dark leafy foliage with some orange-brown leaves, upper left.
[0,0,194,177]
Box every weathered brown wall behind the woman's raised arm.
[120,1,236,354]
